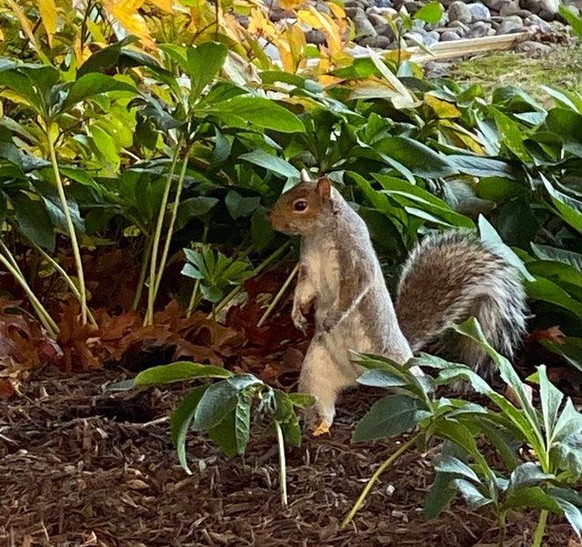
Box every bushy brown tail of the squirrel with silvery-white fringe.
[396,230,526,376]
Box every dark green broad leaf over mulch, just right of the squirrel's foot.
[352,395,419,443]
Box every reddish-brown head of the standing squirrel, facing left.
[268,172,335,235]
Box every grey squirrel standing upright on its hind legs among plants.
[269,173,526,435]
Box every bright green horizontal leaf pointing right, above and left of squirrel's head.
[209,95,305,133]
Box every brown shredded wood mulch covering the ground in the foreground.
[0,369,571,547]
